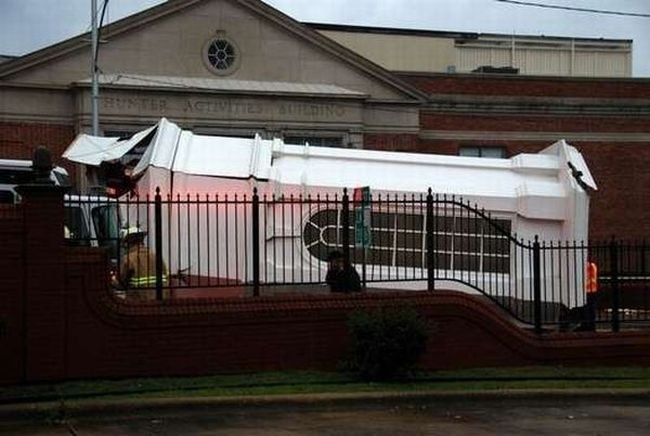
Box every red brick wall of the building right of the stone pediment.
[402,74,650,239]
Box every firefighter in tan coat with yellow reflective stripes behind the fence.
[119,227,169,300]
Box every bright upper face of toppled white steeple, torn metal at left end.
[63,118,596,198]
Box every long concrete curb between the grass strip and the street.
[0,388,650,423]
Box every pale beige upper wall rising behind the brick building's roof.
[320,29,632,77]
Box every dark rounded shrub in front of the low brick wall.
[342,307,429,380]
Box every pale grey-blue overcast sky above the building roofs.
[0,0,650,77]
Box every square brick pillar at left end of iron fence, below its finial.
[16,184,66,381]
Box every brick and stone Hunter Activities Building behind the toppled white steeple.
[0,0,650,238]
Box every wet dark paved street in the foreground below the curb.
[0,399,650,436]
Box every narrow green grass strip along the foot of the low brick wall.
[0,367,650,404]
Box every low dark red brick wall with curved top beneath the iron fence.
[0,190,650,384]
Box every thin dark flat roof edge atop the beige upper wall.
[302,22,633,44]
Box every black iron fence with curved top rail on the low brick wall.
[66,190,650,331]
